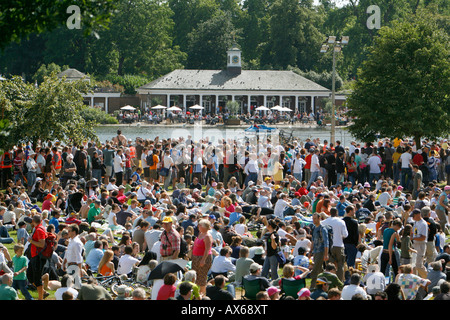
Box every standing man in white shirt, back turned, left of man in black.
[322,207,348,282]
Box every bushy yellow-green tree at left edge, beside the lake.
[0,73,97,148]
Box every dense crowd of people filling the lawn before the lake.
[0,130,450,300]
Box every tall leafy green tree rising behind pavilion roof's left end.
[99,0,185,79]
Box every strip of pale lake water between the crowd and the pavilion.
[95,124,354,146]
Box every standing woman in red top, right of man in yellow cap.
[192,219,213,293]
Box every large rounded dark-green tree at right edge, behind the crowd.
[348,13,450,145]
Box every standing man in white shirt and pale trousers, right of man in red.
[62,224,84,290]
